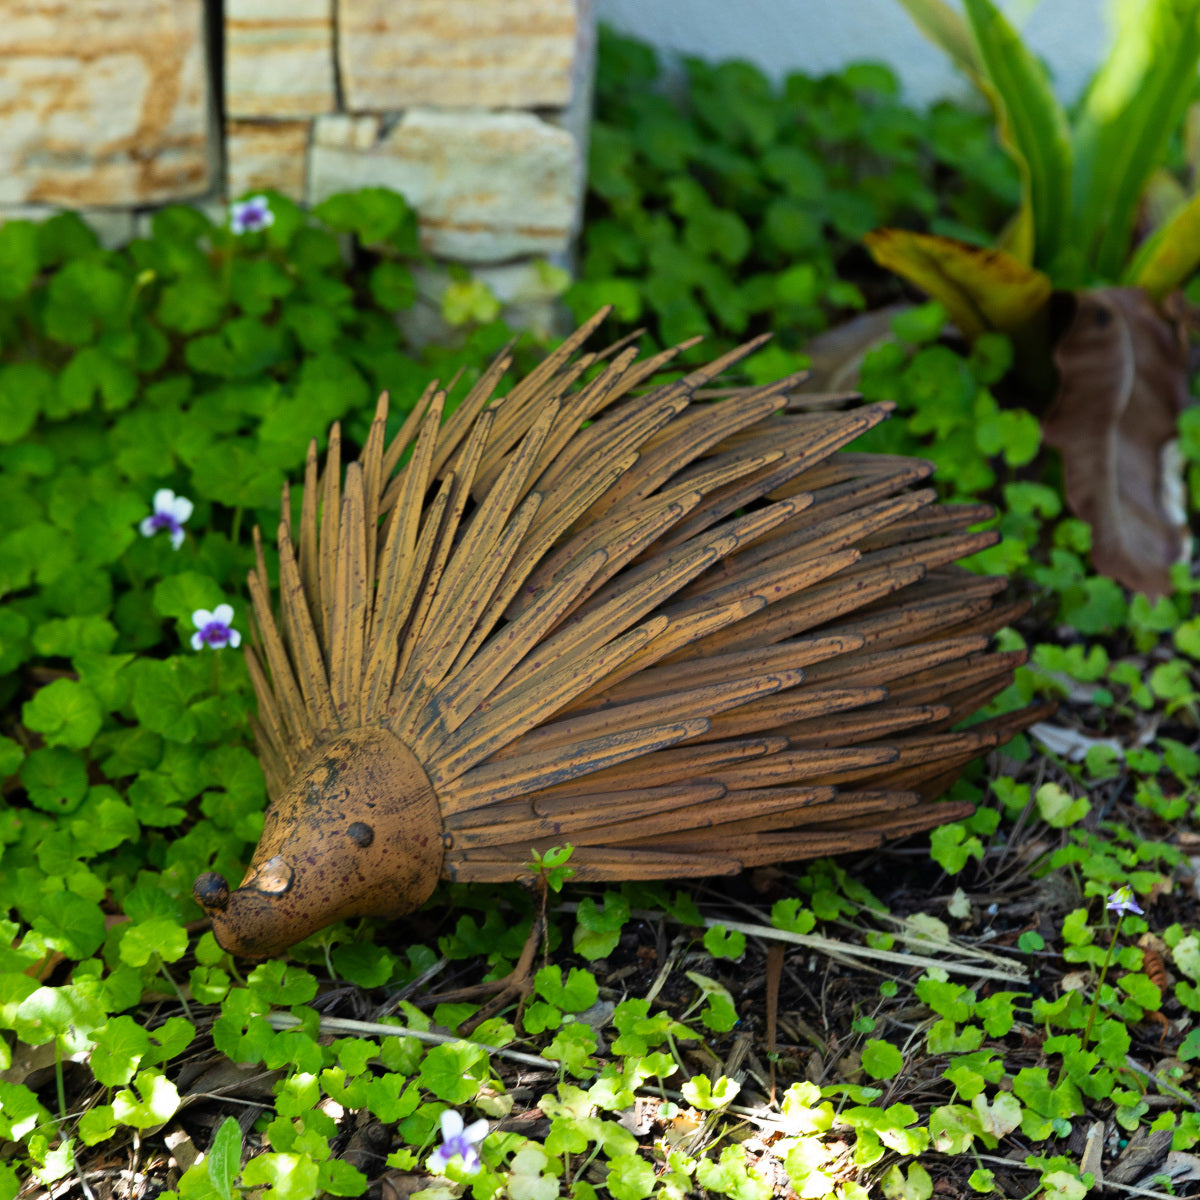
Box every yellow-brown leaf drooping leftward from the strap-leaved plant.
[863,229,1054,341]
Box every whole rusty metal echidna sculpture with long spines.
[196,318,1033,955]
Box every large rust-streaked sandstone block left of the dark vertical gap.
[0,0,214,208]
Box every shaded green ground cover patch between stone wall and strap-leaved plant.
[566,30,1019,374]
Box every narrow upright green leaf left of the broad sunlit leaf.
[964,0,1072,265]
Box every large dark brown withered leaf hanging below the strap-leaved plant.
[1043,288,1190,596]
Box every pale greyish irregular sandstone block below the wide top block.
[308,109,583,263]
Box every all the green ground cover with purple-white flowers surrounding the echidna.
[0,25,1200,1200]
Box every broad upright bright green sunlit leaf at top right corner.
[1073,0,1200,280]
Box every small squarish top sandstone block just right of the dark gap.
[224,0,337,118]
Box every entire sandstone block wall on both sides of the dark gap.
[0,0,594,295]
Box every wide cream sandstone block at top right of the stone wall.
[337,0,582,112]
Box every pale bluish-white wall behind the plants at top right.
[596,0,1109,104]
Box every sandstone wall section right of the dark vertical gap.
[224,0,593,263]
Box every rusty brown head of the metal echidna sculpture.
[192,728,443,958]
